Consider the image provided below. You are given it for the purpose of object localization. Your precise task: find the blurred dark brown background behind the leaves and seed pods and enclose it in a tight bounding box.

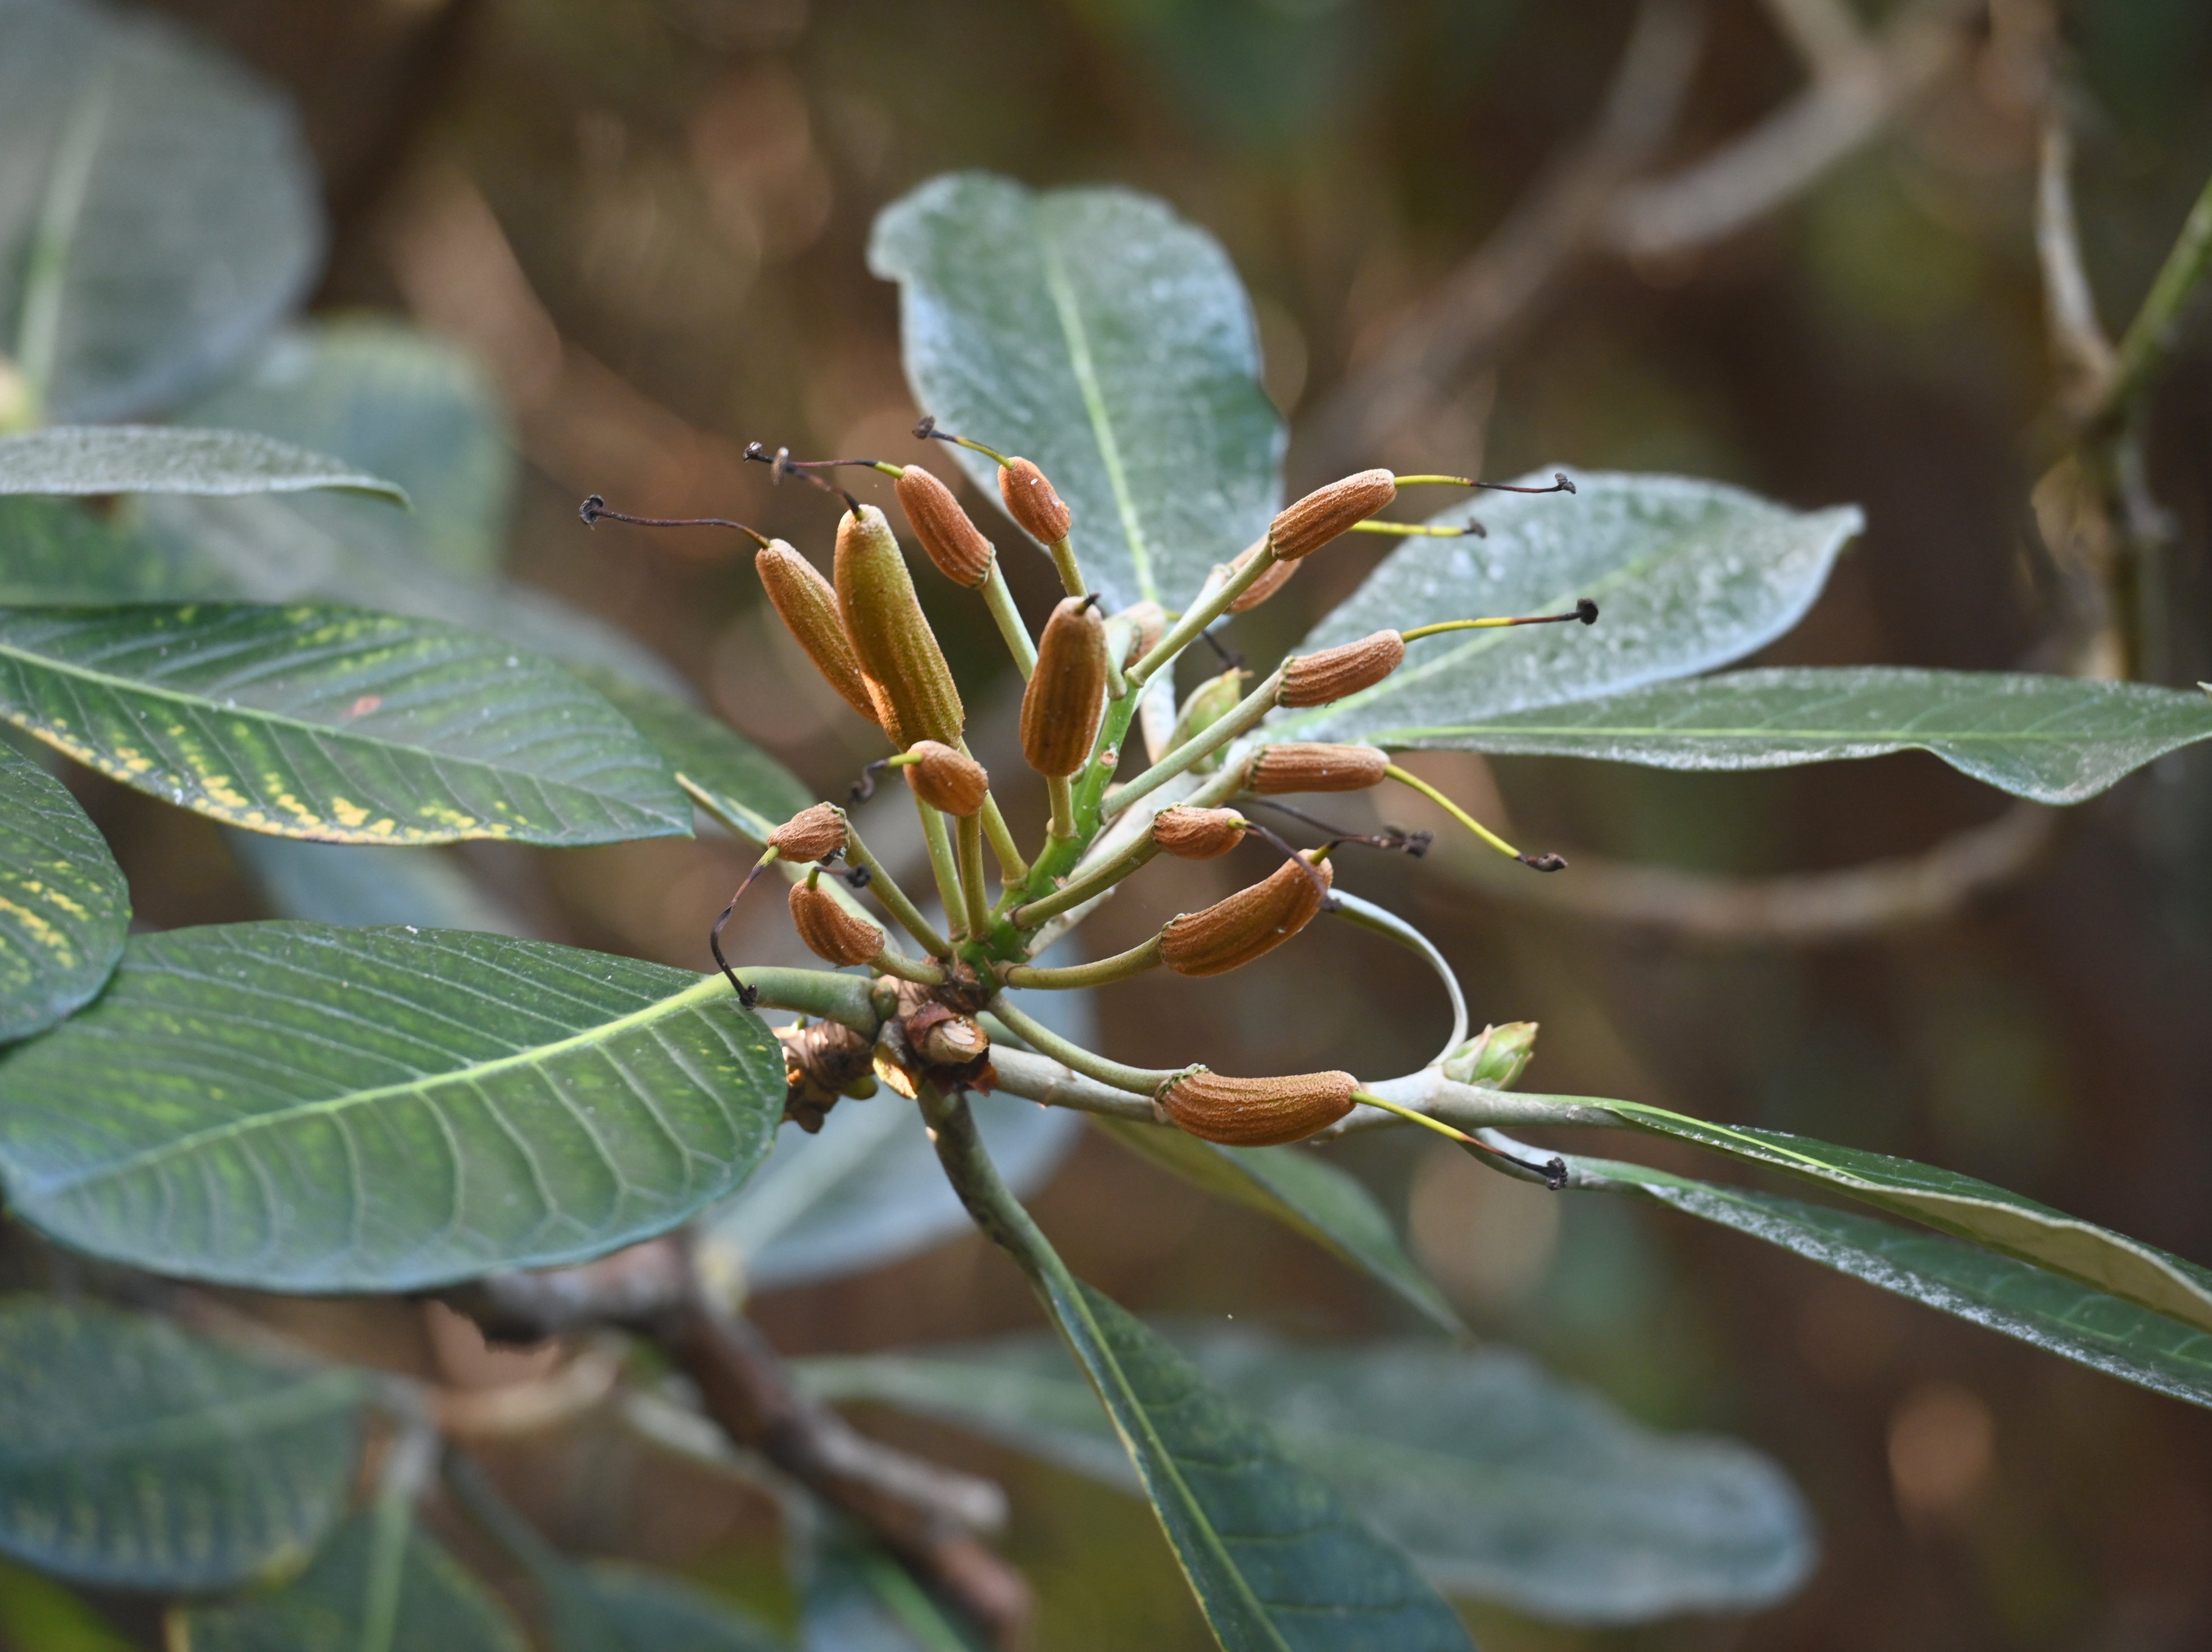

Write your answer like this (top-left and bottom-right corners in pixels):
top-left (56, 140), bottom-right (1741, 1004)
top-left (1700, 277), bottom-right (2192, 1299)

top-left (43, 0), bottom-right (2212, 1652)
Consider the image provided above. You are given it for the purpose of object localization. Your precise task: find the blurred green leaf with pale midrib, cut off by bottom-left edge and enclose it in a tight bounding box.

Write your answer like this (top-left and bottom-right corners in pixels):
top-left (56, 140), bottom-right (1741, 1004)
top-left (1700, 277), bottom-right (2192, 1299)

top-left (168, 1508), bottom-right (529, 1652)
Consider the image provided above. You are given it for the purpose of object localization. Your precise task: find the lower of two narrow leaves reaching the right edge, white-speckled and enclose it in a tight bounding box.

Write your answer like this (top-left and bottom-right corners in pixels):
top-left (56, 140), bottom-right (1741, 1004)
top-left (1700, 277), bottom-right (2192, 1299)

top-left (1568, 1159), bottom-right (2212, 1407)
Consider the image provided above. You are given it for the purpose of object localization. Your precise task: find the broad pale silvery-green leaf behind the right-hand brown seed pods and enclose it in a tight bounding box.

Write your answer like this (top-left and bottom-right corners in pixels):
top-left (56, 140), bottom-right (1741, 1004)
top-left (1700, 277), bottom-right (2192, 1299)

top-left (1263, 471), bottom-right (1860, 741)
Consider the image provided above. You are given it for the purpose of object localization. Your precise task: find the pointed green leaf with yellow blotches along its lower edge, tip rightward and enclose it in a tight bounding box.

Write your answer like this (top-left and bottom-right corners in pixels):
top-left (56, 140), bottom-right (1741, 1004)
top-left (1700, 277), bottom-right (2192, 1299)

top-left (0, 604), bottom-right (690, 845)
